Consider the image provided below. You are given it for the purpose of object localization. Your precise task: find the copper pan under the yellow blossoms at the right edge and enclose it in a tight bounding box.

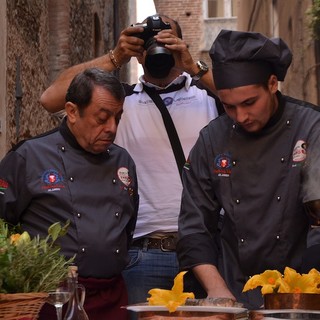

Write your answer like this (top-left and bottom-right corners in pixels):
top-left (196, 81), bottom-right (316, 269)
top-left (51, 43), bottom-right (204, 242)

top-left (264, 293), bottom-right (320, 310)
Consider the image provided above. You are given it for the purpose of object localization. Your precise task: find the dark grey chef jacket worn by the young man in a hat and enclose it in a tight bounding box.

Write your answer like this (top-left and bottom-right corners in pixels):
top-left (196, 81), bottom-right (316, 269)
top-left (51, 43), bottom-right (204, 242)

top-left (178, 92), bottom-right (320, 308)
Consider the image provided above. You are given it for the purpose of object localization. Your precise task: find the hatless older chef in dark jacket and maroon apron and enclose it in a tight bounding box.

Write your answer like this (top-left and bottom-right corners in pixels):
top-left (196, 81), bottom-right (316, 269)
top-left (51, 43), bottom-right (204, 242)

top-left (0, 69), bottom-right (138, 320)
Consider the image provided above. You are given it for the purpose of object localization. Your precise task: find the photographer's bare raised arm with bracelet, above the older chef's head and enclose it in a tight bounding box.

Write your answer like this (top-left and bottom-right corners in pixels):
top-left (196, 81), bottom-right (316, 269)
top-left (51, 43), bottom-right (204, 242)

top-left (40, 27), bottom-right (144, 113)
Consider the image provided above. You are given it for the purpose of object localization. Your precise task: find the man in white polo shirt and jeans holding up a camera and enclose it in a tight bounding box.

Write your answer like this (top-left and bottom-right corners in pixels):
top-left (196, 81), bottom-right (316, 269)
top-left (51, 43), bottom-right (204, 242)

top-left (41, 15), bottom-right (219, 316)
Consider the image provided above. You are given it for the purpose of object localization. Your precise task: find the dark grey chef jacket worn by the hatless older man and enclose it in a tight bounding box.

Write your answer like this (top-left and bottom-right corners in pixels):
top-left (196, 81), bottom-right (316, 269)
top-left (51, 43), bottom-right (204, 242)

top-left (0, 121), bottom-right (138, 278)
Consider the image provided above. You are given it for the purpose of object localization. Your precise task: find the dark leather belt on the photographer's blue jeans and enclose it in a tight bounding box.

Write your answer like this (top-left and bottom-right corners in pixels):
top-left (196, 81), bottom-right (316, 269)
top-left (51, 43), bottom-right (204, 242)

top-left (131, 235), bottom-right (177, 252)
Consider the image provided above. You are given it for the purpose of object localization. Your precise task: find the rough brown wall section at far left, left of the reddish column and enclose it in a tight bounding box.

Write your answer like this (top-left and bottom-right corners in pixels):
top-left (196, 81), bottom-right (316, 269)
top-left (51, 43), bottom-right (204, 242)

top-left (6, 0), bottom-right (55, 150)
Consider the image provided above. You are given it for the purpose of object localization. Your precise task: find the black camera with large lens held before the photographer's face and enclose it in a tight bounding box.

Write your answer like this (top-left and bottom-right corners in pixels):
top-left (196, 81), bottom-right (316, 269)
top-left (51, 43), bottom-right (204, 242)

top-left (133, 16), bottom-right (175, 78)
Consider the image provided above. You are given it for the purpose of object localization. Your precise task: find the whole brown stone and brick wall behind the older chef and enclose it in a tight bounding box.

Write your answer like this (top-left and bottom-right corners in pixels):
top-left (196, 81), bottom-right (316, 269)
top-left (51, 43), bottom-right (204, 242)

top-left (0, 0), bottom-right (129, 158)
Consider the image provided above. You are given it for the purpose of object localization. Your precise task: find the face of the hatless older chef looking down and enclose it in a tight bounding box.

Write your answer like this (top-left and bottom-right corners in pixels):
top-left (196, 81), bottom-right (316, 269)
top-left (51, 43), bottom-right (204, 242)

top-left (66, 86), bottom-right (123, 154)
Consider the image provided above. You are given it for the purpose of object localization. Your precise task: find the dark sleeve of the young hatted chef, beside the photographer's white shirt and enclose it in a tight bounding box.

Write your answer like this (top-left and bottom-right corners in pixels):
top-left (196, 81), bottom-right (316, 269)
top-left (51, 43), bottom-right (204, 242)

top-left (177, 130), bottom-right (220, 269)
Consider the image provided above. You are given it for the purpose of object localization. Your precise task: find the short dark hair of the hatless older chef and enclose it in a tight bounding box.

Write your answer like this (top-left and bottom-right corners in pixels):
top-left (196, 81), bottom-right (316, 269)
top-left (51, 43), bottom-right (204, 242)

top-left (66, 68), bottom-right (125, 114)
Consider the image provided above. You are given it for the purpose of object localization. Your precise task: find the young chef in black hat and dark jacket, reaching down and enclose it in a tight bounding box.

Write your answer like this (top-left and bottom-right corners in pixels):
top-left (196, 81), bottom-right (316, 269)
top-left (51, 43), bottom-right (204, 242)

top-left (177, 30), bottom-right (320, 309)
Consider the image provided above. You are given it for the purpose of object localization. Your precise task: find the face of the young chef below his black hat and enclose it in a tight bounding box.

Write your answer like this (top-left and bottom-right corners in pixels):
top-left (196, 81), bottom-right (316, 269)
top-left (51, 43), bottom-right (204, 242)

top-left (218, 76), bottom-right (278, 133)
